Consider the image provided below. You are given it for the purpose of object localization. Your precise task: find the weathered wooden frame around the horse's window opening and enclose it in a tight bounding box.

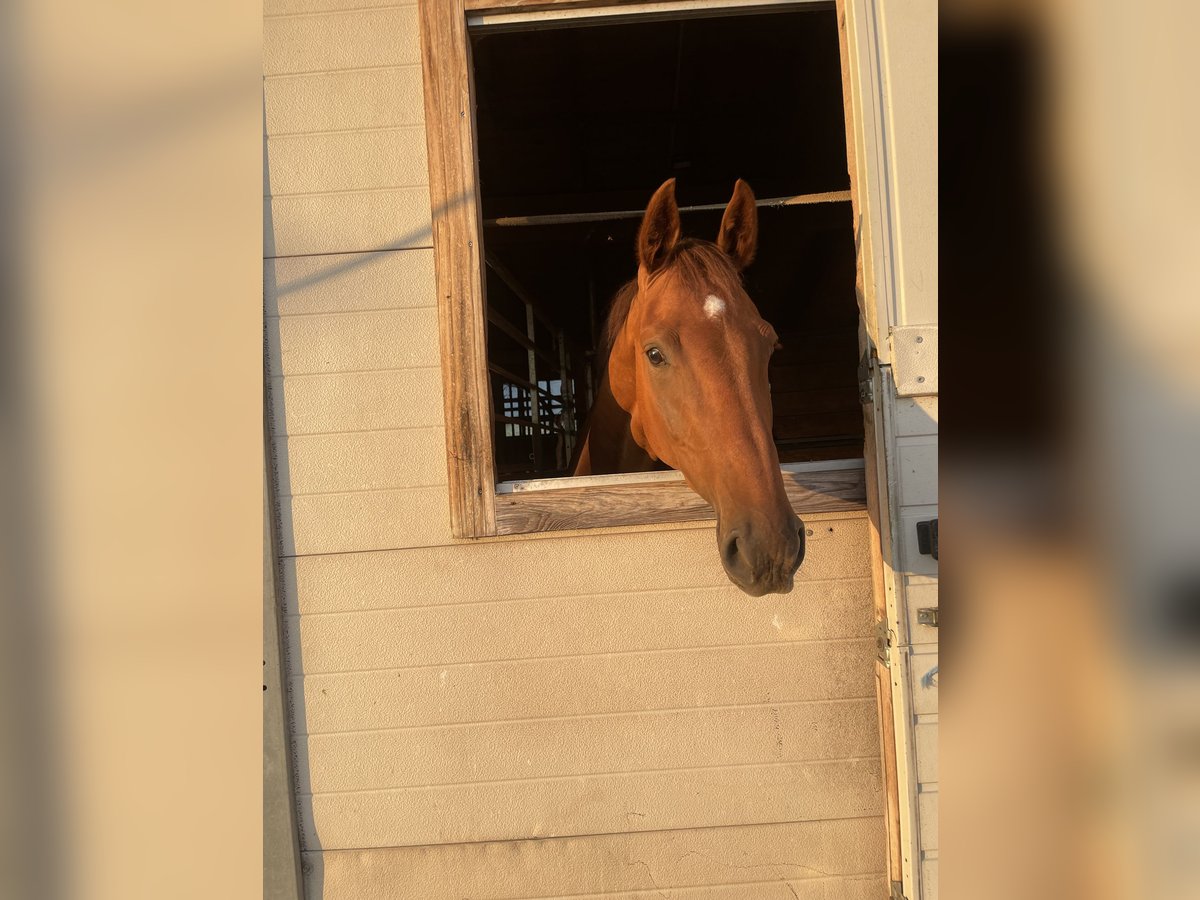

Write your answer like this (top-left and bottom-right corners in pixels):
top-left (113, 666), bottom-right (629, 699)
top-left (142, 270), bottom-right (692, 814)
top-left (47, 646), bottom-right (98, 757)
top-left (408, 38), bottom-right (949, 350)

top-left (418, 0), bottom-right (866, 538)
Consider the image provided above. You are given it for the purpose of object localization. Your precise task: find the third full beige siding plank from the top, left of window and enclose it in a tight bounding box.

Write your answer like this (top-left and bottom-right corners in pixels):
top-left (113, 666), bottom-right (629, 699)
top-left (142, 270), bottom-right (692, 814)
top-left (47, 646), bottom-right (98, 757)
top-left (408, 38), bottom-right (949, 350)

top-left (263, 125), bottom-right (428, 197)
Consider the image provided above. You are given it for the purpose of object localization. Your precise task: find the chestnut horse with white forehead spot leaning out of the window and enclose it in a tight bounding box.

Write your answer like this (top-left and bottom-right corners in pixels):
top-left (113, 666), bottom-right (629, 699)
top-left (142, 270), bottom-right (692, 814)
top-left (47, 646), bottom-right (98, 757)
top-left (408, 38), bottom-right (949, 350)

top-left (574, 179), bottom-right (804, 596)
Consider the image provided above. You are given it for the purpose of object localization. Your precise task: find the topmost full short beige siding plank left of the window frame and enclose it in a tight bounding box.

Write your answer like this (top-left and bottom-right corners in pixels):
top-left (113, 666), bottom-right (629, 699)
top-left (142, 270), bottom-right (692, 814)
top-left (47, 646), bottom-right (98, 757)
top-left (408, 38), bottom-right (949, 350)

top-left (263, 6), bottom-right (421, 76)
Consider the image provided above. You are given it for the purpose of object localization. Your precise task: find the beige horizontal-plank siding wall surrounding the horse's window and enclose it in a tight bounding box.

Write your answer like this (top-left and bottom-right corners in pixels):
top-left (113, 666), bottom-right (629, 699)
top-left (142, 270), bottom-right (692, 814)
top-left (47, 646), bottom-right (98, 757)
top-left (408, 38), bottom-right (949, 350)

top-left (264, 0), bottom-right (884, 900)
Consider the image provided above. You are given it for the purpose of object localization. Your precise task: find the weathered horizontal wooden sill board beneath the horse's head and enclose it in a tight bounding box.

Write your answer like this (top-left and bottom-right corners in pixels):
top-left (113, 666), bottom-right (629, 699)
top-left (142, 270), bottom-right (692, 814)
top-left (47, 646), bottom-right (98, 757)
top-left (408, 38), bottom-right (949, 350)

top-left (496, 467), bottom-right (866, 534)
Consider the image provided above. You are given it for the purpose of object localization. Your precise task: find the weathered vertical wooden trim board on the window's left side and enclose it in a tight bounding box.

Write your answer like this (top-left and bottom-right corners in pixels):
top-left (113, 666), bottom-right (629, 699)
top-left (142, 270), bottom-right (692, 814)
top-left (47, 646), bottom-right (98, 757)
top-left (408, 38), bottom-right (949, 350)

top-left (418, 0), bottom-right (496, 538)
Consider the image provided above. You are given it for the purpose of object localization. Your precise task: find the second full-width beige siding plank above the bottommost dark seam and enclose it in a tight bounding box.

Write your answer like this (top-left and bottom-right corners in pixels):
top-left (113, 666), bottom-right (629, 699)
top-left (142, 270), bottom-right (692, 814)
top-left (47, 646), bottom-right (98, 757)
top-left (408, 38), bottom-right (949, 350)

top-left (296, 698), bottom-right (878, 793)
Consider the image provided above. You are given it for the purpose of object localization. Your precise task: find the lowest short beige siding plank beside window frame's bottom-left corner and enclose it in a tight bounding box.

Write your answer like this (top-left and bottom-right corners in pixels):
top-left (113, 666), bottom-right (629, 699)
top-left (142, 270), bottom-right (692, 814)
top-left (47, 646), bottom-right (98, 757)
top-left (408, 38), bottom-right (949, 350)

top-left (280, 487), bottom-right (450, 556)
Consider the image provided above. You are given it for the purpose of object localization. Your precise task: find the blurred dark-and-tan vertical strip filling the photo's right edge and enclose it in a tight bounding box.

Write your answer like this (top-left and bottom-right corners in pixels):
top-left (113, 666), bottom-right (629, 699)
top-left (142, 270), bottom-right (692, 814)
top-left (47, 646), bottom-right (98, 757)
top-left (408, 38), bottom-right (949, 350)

top-left (940, 0), bottom-right (1200, 898)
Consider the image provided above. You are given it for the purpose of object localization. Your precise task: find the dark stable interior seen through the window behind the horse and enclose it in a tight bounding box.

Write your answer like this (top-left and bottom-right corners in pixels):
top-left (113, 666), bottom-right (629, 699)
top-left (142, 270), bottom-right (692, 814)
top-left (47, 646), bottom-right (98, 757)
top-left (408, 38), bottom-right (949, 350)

top-left (472, 4), bottom-right (863, 480)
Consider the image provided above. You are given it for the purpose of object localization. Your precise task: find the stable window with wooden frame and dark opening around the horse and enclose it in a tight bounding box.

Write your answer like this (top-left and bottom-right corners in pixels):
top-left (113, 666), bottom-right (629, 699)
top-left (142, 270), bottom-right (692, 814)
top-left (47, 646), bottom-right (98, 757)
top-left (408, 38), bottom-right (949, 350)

top-left (420, 0), bottom-right (865, 536)
